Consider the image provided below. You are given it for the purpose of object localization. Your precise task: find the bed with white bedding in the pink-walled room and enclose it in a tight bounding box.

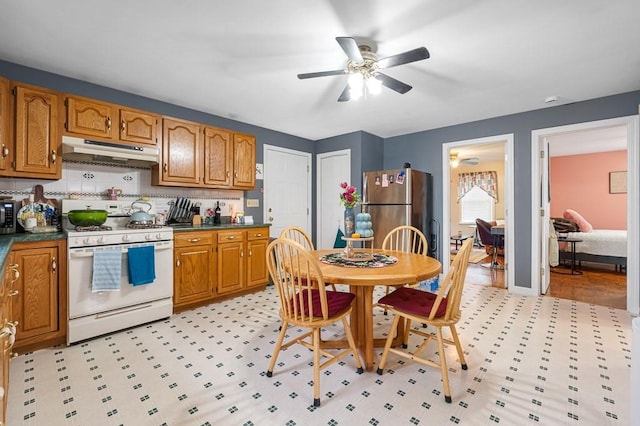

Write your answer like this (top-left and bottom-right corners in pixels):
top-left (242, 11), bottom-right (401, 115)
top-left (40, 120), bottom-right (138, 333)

top-left (558, 229), bottom-right (627, 268)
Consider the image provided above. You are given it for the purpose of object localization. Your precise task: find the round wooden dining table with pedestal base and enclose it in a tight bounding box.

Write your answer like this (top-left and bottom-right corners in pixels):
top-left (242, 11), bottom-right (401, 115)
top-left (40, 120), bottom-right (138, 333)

top-left (312, 249), bottom-right (442, 370)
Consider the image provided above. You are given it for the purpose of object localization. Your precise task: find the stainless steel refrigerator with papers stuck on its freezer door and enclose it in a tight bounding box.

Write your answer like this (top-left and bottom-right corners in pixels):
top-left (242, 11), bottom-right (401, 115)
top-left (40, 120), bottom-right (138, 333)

top-left (361, 168), bottom-right (436, 257)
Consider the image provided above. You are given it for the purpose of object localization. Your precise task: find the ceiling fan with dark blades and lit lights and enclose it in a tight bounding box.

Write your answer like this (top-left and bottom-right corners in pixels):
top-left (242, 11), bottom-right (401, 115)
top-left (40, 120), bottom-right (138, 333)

top-left (298, 37), bottom-right (429, 102)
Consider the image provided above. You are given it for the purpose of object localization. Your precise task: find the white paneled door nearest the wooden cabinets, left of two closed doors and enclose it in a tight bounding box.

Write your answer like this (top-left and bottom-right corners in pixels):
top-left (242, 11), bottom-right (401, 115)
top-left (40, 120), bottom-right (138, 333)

top-left (264, 145), bottom-right (311, 238)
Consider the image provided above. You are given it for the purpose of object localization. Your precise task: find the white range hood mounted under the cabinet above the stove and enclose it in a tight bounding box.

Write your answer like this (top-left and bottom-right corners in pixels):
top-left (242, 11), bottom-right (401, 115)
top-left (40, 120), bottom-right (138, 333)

top-left (62, 136), bottom-right (160, 167)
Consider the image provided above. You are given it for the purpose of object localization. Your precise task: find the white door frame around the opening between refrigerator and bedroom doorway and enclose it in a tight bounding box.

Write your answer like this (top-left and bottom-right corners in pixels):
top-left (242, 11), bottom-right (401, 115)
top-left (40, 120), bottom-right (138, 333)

top-left (442, 134), bottom-right (515, 291)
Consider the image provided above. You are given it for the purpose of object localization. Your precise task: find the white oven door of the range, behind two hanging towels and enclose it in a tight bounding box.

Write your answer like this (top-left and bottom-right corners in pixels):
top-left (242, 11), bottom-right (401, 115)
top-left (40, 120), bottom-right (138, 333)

top-left (68, 241), bottom-right (173, 320)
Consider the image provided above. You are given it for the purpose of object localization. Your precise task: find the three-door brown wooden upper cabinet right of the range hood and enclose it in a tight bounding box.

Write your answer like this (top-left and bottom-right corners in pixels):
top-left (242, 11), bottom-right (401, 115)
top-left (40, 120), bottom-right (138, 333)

top-left (151, 118), bottom-right (256, 190)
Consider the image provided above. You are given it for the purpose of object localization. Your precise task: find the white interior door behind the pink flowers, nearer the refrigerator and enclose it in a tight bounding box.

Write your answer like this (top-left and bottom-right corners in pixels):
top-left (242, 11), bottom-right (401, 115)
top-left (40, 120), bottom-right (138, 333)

top-left (316, 149), bottom-right (352, 249)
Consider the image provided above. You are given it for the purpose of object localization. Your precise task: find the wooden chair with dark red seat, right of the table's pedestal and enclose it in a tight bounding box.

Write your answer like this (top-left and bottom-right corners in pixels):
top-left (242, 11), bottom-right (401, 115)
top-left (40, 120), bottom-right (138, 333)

top-left (378, 238), bottom-right (473, 403)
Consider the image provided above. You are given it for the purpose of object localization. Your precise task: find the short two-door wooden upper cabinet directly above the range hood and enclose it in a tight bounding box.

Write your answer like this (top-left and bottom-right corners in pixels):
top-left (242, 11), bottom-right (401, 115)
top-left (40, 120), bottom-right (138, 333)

top-left (65, 96), bottom-right (159, 146)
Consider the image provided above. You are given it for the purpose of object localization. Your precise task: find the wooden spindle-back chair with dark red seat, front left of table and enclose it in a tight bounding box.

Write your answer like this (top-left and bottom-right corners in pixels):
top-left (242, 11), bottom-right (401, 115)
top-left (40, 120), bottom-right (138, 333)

top-left (267, 238), bottom-right (363, 407)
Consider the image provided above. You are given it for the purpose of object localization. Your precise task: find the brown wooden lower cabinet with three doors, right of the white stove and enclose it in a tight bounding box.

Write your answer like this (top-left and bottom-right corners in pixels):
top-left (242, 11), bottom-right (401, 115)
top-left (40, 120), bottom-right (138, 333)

top-left (173, 227), bottom-right (269, 312)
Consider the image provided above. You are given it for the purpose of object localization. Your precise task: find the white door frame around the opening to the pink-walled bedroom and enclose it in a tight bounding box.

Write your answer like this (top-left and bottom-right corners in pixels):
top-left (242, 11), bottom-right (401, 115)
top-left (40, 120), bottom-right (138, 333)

top-left (531, 116), bottom-right (640, 314)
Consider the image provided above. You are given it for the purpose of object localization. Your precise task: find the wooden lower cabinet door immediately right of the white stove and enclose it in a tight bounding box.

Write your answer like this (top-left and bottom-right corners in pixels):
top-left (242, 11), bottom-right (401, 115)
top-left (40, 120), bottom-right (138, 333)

top-left (173, 245), bottom-right (212, 306)
